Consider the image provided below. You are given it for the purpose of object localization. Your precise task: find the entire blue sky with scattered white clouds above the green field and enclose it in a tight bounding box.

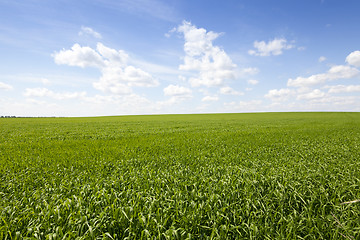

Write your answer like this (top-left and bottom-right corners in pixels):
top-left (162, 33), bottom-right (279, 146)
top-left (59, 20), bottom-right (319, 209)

top-left (0, 0), bottom-right (360, 116)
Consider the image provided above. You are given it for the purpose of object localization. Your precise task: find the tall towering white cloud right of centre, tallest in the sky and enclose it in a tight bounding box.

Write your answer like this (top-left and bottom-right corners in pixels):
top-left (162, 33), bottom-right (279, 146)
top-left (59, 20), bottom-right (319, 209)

top-left (177, 21), bottom-right (236, 87)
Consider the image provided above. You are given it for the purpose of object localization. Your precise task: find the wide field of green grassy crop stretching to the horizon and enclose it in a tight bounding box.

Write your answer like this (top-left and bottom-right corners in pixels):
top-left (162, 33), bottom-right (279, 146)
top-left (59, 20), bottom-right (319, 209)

top-left (0, 113), bottom-right (360, 239)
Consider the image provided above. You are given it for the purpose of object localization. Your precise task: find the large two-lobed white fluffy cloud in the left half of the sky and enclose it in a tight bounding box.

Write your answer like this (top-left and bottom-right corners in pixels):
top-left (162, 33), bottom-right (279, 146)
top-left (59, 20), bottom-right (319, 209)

top-left (53, 43), bottom-right (159, 95)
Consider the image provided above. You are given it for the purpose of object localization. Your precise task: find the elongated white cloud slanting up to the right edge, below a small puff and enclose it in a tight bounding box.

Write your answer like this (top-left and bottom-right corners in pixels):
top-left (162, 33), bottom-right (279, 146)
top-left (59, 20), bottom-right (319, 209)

top-left (287, 65), bottom-right (360, 87)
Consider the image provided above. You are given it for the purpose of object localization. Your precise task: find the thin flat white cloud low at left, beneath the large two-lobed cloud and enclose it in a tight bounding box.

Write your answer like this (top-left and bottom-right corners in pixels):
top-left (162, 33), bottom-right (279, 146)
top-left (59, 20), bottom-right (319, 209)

top-left (24, 88), bottom-right (86, 100)
